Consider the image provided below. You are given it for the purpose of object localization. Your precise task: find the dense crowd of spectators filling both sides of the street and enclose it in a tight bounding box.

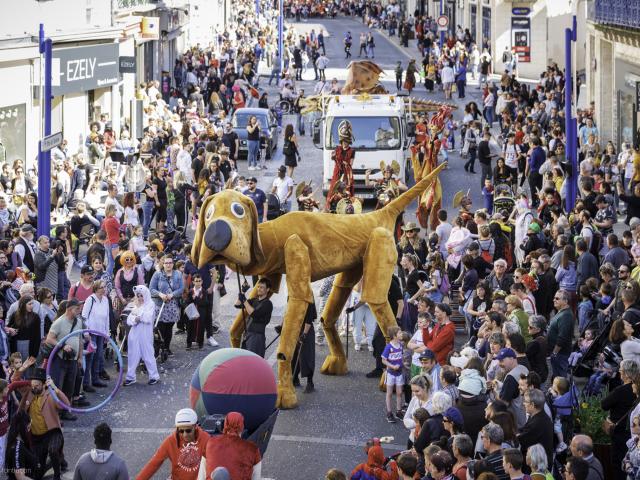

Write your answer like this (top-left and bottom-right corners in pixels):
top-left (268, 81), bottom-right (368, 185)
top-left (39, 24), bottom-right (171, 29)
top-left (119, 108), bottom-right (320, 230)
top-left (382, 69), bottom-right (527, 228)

top-left (0, 1), bottom-right (640, 480)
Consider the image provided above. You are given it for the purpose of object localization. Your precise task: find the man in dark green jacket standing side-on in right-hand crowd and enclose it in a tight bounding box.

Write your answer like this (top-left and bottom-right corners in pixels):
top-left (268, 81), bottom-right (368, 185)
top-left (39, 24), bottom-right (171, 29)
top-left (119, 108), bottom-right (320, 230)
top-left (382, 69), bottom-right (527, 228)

top-left (547, 290), bottom-right (575, 379)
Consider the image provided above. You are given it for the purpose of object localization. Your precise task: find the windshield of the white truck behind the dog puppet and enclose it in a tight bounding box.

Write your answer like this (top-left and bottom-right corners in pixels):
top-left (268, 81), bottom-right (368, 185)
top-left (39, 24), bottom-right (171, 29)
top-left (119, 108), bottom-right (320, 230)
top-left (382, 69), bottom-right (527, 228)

top-left (325, 117), bottom-right (401, 150)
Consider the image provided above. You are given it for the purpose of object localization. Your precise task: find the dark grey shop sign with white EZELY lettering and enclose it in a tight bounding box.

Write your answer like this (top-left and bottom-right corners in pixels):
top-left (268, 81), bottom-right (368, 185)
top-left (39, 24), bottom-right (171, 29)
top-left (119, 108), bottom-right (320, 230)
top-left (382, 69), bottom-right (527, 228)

top-left (52, 43), bottom-right (120, 96)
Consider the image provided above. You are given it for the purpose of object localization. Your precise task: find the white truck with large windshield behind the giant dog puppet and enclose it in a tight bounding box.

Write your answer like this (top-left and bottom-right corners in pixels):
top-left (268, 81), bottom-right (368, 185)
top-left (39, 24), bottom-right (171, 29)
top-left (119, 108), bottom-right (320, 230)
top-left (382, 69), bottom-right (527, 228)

top-left (313, 94), bottom-right (415, 200)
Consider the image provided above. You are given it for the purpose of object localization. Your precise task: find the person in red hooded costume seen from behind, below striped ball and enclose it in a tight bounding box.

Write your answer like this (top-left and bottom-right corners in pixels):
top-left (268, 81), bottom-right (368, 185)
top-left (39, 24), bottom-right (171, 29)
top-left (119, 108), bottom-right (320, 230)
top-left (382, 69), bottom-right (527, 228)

top-left (205, 412), bottom-right (262, 480)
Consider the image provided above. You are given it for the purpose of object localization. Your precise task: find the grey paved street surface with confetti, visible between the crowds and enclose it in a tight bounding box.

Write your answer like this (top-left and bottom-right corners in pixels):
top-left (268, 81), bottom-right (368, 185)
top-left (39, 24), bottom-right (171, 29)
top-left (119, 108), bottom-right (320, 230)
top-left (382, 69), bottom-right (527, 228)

top-left (65, 18), bottom-right (488, 480)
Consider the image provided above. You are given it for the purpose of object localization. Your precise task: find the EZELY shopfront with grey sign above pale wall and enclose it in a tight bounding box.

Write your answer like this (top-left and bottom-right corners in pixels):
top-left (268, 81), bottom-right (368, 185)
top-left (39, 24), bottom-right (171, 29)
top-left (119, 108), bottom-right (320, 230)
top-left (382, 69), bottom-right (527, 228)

top-left (51, 43), bottom-right (120, 155)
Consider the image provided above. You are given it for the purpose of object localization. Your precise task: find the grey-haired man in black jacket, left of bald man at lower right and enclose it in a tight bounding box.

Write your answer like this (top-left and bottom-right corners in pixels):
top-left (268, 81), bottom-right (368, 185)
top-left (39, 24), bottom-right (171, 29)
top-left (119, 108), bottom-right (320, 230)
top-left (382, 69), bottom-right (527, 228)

top-left (518, 389), bottom-right (553, 465)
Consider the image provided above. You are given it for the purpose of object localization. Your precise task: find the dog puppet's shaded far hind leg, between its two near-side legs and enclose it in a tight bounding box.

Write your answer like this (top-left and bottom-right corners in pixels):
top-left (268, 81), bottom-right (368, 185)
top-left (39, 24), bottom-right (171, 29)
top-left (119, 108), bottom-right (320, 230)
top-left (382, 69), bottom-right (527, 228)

top-left (320, 267), bottom-right (362, 375)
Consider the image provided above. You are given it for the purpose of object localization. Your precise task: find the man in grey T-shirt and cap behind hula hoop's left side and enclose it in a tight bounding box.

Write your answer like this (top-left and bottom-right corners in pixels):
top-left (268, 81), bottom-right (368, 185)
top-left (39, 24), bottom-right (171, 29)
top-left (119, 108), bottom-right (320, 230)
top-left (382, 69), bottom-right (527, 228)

top-left (46, 298), bottom-right (83, 421)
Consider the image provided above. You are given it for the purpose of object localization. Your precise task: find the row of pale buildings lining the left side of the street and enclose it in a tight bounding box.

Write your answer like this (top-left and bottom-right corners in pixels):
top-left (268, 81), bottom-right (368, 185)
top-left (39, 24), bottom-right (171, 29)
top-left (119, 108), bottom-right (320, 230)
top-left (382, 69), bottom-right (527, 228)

top-left (0, 0), bottom-right (229, 168)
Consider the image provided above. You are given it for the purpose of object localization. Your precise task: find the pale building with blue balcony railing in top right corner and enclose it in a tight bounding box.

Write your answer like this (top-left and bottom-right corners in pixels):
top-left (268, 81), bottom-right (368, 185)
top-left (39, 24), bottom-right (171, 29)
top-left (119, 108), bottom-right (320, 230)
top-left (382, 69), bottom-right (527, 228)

top-left (586, 0), bottom-right (640, 148)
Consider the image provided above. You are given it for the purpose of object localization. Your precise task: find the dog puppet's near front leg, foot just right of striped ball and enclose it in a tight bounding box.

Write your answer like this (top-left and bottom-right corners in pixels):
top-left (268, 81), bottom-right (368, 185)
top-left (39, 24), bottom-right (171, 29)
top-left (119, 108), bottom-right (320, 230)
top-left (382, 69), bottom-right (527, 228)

top-left (277, 235), bottom-right (313, 408)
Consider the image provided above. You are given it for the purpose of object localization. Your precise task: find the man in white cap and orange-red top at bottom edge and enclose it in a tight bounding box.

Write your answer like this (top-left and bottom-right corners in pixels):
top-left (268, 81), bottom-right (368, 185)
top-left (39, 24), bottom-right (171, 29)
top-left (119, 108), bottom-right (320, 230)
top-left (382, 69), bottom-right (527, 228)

top-left (136, 408), bottom-right (209, 480)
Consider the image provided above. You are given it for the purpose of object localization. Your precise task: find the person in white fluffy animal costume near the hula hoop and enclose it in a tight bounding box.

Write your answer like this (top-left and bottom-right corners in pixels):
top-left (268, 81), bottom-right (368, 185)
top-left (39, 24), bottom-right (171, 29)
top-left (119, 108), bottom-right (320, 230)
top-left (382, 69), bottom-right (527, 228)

top-left (124, 285), bottom-right (160, 387)
